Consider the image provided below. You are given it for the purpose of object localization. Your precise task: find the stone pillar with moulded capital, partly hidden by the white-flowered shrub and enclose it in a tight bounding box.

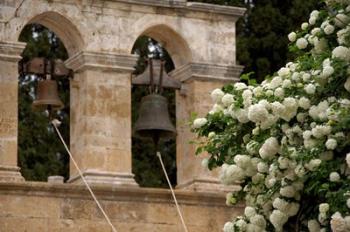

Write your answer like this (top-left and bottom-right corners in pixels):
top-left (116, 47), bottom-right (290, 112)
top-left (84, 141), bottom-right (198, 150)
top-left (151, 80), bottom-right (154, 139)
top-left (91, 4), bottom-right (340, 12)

top-left (171, 63), bottom-right (242, 191)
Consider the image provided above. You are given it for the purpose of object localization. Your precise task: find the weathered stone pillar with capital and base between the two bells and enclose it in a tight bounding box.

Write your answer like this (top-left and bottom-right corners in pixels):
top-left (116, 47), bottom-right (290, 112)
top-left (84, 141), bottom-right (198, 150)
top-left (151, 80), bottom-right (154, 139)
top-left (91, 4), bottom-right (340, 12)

top-left (66, 51), bottom-right (137, 186)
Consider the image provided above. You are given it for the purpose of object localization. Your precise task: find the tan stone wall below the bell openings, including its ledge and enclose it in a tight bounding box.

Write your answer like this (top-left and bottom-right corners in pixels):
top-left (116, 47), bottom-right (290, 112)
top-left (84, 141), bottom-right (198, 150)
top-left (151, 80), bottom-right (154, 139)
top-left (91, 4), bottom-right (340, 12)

top-left (0, 182), bottom-right (242, 232)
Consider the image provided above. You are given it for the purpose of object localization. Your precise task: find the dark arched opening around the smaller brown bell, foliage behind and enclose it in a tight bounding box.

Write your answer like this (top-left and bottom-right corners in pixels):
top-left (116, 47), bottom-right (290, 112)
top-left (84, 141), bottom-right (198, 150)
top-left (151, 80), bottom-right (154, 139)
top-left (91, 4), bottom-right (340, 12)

top-left (18, 24), bottom-right (70, 181)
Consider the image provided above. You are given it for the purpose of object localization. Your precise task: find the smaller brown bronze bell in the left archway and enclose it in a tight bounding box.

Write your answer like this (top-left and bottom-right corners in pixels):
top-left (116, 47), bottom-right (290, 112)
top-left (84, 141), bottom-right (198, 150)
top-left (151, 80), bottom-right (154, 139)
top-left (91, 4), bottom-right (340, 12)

top-left (32, 80), bottom-right (64, 110)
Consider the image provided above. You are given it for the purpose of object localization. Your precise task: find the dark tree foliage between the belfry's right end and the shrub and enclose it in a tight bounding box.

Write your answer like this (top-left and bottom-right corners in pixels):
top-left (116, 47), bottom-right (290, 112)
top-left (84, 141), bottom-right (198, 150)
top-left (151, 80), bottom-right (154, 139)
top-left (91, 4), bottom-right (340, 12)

top-left (237, 0), bottom-right (321, 82)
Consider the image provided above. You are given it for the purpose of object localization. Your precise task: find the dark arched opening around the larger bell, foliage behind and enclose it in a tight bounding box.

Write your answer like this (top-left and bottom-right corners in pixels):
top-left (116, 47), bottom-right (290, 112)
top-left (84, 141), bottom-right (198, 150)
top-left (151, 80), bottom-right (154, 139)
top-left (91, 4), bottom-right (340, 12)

top-left (132, 36), bottom-right (176, 187)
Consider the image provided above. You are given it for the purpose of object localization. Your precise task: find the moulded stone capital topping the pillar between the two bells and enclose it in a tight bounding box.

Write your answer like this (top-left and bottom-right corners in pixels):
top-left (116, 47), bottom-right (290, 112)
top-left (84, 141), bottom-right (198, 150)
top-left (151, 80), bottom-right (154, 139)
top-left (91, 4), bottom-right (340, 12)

top-left (65, 51), bottom-right (138, 72)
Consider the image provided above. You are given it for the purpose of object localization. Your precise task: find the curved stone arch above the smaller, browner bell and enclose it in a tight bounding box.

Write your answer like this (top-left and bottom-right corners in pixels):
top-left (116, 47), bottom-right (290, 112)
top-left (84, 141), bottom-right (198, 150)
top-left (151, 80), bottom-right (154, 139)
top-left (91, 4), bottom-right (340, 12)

top-left (17, 11), bottom-right (85, 57)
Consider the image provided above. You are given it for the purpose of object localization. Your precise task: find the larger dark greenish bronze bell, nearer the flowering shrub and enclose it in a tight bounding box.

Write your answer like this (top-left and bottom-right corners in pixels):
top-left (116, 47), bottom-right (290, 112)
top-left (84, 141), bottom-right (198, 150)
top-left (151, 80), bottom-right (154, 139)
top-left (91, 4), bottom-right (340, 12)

top-left (134, 94), bottom-right (176, 143)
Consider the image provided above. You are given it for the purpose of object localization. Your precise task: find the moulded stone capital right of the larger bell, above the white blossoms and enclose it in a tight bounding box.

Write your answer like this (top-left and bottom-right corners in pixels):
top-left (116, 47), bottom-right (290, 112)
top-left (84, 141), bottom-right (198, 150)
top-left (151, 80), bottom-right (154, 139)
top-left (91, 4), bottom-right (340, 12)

top-left (170, 63), bottom-right (243, 82)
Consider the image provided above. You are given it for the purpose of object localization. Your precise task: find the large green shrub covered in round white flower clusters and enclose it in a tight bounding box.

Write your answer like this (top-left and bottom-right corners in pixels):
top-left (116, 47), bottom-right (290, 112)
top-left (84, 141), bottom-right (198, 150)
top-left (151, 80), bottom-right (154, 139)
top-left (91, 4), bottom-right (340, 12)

top-left (193, 0), bottom-right (350, 232)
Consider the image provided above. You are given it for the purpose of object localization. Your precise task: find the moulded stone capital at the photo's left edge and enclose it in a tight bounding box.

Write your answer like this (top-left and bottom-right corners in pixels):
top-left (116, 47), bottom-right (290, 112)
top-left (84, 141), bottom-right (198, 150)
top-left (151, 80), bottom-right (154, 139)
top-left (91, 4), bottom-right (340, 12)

top-left (0, 41), bottom-right (26, 62)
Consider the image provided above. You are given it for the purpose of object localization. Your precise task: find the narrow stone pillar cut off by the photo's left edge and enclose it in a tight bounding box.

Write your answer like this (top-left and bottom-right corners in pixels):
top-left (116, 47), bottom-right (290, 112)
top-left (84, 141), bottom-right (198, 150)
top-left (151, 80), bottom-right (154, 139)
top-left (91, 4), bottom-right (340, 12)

top-left (0, 41), bottom-right (25, 182)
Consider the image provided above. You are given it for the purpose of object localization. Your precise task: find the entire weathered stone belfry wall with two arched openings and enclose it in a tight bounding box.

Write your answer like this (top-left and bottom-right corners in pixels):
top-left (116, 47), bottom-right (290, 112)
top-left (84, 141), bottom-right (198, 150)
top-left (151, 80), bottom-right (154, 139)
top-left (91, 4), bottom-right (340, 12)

top-left (0, 0), bottom-right (244, 232)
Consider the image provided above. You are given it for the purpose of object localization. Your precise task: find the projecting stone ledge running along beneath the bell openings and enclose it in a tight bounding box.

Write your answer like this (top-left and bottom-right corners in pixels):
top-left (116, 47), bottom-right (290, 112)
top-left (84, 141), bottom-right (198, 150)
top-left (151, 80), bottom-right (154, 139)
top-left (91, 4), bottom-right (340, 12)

top-left (0, 182), bottom-right (235, 207)
